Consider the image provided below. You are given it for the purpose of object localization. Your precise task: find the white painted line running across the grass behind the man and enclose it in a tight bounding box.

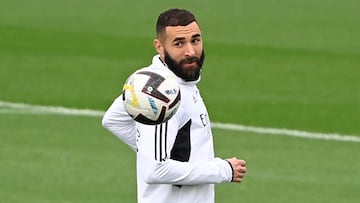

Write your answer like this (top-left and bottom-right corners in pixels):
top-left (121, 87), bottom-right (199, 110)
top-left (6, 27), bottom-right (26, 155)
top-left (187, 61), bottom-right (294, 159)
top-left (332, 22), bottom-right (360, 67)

top-left (0, 100), bottom-right (360, 142)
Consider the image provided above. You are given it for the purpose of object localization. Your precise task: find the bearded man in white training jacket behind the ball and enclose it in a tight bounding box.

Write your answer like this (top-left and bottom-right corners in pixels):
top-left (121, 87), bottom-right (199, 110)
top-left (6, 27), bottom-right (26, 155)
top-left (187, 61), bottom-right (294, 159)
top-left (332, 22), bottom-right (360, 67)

top-left (103, 9), bottom-right (246, 203)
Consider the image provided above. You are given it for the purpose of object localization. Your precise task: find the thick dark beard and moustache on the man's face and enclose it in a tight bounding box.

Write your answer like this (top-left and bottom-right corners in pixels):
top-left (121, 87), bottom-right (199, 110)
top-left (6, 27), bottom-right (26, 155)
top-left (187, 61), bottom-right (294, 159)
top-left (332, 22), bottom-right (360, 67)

top-left (164, 50), bottom-right (205, 81)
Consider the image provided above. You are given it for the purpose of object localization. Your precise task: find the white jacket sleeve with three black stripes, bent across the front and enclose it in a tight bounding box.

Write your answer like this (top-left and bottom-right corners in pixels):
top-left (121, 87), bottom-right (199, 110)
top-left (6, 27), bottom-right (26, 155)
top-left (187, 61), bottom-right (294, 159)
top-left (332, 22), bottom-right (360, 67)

top-left (137, 116), bottom-right (233, 185)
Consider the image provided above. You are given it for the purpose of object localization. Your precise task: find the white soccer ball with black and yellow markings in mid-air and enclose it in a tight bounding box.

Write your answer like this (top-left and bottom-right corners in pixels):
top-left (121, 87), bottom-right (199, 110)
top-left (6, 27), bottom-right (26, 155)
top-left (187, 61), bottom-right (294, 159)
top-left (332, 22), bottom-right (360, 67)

top-left (122, 69), bottom-right (180, 125)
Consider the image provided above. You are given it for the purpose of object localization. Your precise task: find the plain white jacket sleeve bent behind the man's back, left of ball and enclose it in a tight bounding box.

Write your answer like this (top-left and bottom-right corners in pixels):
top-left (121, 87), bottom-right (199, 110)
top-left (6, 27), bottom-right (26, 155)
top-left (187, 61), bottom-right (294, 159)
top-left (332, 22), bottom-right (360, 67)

top-left (102, 95), bottom-right (137, 151)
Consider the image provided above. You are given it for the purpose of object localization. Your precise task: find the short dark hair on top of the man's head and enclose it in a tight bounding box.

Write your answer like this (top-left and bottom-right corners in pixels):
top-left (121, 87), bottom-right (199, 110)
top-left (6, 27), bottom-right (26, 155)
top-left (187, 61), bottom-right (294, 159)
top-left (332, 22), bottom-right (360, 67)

top-left (156, 8), bottom-right (197, 37)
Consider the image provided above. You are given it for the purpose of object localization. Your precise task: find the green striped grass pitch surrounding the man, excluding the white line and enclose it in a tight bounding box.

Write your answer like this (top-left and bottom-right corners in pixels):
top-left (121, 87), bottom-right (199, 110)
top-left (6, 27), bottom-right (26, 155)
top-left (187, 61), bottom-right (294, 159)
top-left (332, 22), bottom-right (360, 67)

top-left (0, 0), bottom-right (360, 203)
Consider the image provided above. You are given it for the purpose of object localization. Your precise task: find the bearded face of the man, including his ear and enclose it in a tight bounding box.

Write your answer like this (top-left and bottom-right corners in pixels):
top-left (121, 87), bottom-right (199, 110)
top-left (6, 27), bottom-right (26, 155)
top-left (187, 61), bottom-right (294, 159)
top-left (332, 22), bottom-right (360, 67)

top-left (155, 22), bottom-right (205, 81)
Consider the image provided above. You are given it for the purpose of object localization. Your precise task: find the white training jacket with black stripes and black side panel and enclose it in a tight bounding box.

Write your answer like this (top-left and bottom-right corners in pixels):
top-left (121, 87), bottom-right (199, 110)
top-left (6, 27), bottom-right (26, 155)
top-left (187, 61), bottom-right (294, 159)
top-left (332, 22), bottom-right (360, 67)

top-left (102, 55), bottom-right (233, 203)
